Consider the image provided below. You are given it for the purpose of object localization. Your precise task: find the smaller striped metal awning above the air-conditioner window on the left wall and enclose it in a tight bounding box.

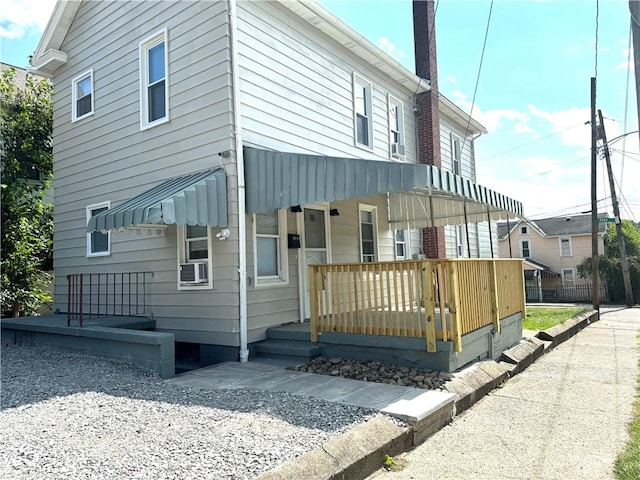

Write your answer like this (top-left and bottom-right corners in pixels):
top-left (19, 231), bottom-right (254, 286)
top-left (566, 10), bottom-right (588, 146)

top-left (87, 167), bottom-right (227, 233)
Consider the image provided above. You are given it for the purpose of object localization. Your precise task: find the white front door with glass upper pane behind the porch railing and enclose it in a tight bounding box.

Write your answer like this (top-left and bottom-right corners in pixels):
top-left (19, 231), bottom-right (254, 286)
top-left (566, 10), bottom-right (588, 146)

top-left (302, 205), bottom-right (331, 318)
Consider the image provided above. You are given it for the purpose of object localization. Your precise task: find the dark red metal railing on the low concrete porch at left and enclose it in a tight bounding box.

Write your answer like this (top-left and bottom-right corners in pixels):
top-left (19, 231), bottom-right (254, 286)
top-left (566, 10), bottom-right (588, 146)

top-left (67, 272), bottom-right (152, 327)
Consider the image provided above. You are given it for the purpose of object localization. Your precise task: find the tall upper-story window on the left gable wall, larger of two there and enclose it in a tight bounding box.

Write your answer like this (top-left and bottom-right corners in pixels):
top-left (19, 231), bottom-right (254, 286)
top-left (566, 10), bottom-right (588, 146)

top-left (140, 29), bottom-right (169, 129)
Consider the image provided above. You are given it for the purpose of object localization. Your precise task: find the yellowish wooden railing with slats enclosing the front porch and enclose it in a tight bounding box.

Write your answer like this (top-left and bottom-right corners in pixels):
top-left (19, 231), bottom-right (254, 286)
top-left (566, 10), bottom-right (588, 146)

top-left (309, 259), bottom-right (525, 352)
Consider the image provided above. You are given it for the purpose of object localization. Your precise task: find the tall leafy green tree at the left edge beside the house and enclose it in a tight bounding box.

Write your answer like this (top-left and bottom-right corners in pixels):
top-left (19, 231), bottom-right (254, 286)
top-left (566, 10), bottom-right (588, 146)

top-left (0, 65), bottom-right (53, 316)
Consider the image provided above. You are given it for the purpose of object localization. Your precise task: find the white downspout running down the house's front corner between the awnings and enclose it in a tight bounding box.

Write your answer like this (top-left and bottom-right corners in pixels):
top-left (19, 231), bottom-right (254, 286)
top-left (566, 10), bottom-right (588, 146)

top-left (229, 0), bottom-right (249, 363)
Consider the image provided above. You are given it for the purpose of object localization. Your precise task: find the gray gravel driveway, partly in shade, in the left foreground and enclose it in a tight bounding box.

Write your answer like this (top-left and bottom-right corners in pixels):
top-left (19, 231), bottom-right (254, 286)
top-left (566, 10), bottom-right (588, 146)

top-left (0, 344), bottom-right (374, 480)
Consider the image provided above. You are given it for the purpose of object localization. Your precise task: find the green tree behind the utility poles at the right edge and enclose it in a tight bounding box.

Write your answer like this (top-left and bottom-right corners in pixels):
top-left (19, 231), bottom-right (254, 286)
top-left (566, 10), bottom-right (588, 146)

top-left (578, 220), bottom-right (640, 302)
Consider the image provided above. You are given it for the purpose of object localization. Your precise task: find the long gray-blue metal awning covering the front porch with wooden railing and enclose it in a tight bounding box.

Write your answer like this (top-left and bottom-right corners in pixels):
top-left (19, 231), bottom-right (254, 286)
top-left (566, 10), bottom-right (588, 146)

top-left (244, 147), bottom-right (522, 229)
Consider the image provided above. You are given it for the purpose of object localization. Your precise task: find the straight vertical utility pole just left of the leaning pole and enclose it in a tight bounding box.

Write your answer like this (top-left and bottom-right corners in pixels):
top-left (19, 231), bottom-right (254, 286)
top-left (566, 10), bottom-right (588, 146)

top-left (591, 77), bottom-right (600, 318)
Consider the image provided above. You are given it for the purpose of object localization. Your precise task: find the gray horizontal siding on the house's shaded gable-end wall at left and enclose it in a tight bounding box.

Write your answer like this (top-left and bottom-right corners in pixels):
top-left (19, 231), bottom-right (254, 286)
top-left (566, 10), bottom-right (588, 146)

top-left (49, 1), bottom-right (238, 344)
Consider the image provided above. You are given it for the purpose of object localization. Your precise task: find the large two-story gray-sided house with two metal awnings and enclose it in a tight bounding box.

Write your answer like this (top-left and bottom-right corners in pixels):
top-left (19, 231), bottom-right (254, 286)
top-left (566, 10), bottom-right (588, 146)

top-left (33, 0), bottom-right (522, 360)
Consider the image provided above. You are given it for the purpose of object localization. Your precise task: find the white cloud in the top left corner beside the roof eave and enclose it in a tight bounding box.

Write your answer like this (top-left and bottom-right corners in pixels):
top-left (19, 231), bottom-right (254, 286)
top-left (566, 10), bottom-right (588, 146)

top-left (0, 0), bottom-right (55, 38)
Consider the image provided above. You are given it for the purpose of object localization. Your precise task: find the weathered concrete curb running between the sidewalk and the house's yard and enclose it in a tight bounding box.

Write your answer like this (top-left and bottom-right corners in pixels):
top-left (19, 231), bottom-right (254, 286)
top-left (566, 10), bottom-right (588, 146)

top-left (258, 310), bottom-right (599, 480)
